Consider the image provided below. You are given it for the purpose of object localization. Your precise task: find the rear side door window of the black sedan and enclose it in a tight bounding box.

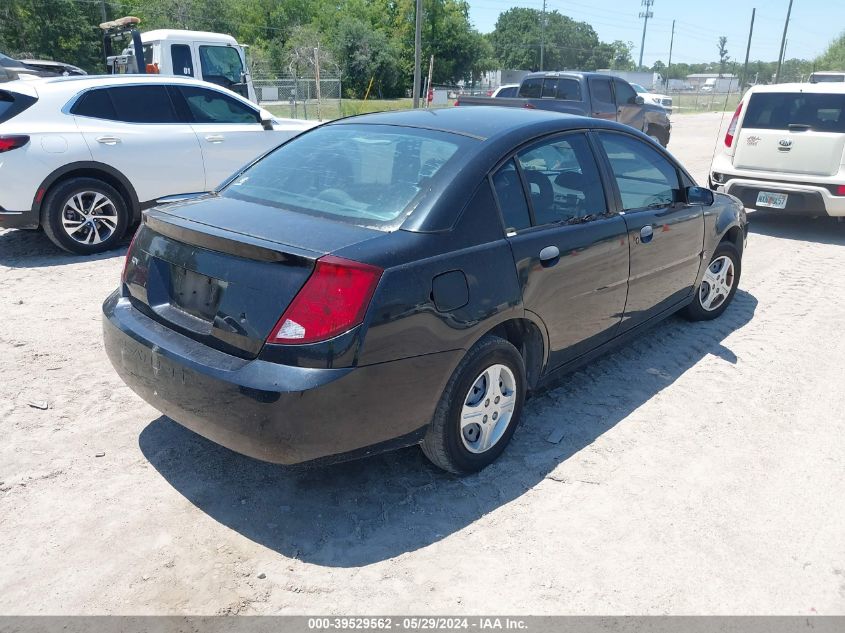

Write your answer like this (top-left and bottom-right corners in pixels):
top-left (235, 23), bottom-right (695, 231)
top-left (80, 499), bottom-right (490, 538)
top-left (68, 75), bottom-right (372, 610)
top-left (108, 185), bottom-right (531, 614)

top-left (517, 134), bottom-right (607, 225)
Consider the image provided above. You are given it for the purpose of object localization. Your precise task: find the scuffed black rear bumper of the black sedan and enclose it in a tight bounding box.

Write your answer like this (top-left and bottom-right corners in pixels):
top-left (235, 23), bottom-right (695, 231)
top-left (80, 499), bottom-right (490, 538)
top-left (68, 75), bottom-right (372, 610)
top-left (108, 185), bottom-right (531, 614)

top-left (103, 292), bottom-right (461, 464)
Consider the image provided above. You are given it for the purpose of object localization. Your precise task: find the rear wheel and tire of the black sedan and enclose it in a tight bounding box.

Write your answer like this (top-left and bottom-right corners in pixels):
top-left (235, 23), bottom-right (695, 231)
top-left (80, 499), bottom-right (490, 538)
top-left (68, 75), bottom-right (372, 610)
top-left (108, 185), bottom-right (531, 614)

top-left (422, 335), bottom-right (527, 475)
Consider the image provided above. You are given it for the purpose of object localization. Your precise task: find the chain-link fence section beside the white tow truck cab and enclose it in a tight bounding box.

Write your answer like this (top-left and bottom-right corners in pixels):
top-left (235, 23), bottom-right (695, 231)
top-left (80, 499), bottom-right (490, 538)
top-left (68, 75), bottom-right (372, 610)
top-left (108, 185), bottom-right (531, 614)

top-left (252, 73), bottom-right (343, 119)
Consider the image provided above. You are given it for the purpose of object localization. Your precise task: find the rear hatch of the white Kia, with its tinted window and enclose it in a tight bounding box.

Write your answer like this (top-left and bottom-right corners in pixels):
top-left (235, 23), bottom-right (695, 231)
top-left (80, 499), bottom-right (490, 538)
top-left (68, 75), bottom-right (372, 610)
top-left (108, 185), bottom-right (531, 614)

top-left (733, 92), bottom-right (845, 176)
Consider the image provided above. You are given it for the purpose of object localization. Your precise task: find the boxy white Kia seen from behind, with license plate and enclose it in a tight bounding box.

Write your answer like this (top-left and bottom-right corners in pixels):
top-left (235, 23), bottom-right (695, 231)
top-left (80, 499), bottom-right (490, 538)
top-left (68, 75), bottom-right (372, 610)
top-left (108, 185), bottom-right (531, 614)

top-left (710, 83), bottom-right (845, 217)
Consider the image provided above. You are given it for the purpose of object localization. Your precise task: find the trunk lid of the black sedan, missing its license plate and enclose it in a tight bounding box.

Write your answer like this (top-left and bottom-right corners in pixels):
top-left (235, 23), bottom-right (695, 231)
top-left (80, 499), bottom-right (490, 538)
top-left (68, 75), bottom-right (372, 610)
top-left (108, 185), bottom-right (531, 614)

top-left (124, 198), bottom-right (380, 358)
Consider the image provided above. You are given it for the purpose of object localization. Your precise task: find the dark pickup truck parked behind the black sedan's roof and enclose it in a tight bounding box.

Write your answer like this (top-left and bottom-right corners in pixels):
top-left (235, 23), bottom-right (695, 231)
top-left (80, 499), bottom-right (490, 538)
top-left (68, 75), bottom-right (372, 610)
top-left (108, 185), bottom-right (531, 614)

top-left (455, 72), bottom-right (672, 147)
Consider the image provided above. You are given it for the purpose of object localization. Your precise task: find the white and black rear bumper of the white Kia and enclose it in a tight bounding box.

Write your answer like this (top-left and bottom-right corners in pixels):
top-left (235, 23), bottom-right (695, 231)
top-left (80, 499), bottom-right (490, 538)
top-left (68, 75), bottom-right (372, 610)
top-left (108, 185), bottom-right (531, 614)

top-left (710, 170), bottom-right (845, 217)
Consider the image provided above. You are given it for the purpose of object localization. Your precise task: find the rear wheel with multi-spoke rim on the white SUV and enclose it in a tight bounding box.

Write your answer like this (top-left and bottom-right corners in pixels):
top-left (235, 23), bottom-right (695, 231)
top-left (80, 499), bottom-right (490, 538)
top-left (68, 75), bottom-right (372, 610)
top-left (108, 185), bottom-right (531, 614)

top-left (41, 178), bottom-right (129, 255)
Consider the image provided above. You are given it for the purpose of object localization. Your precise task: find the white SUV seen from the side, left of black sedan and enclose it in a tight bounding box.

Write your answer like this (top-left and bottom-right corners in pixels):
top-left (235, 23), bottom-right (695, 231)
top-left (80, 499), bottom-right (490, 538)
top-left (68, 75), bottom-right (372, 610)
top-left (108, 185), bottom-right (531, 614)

top-left (0, 75), bottom-right (314, 254)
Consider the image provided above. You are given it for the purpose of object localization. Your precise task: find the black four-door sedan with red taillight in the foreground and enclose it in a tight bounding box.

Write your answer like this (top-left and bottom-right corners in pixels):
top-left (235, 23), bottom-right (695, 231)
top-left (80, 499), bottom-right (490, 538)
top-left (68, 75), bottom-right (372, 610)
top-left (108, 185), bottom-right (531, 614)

top-left (103, 107), bottom-right (746, 473)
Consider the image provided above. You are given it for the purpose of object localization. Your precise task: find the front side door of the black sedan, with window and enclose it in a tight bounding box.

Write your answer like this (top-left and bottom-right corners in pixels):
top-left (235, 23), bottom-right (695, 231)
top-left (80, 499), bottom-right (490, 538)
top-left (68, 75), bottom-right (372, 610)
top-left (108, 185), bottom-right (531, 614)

top-left (596, 132), bottom-right (704, 331)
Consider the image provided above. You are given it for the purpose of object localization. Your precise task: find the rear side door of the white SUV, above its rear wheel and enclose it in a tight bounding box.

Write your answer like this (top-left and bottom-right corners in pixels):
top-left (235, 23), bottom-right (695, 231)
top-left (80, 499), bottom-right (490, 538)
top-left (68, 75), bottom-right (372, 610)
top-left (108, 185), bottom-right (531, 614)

top-left (71, 84), bottom-right (205, 204)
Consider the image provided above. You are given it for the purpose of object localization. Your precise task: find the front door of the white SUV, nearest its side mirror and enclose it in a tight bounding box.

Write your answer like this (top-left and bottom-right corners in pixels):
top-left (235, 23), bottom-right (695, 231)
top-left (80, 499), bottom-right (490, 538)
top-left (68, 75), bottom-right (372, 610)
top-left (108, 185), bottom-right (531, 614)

top-left (174, 86), bottom-right (282, 190)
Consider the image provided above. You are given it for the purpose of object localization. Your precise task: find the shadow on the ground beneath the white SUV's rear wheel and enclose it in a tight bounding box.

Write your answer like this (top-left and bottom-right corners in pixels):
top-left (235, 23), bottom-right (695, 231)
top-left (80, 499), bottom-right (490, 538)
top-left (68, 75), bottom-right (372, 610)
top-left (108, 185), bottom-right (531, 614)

top-left (0, 229), bottom-right (132, 268)
